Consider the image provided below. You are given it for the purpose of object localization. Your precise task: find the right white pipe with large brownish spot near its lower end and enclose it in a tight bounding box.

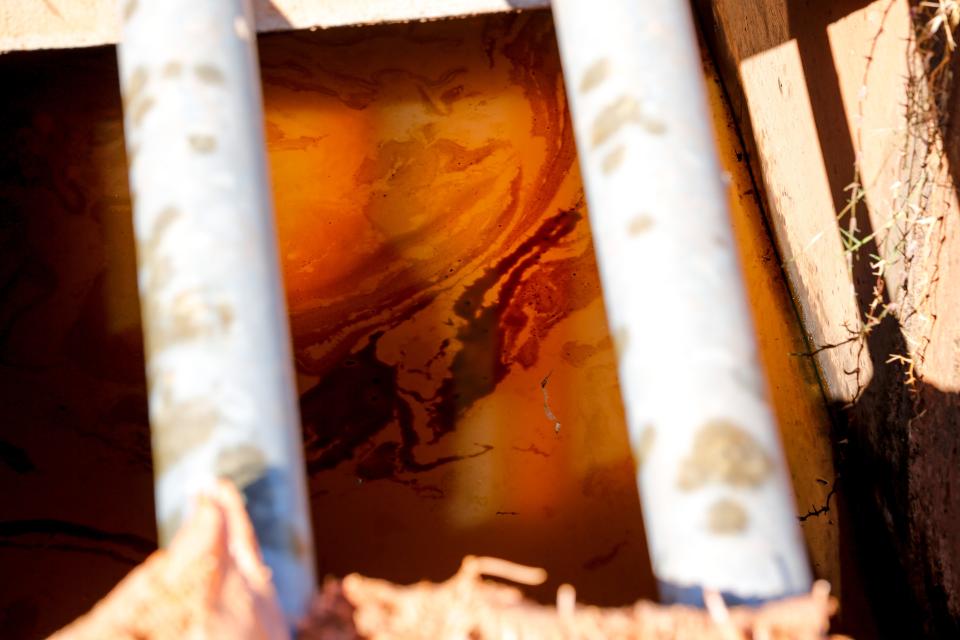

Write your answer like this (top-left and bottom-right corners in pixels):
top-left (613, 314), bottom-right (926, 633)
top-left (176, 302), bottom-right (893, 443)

top-left (553, 0), bottom-right (811, 604)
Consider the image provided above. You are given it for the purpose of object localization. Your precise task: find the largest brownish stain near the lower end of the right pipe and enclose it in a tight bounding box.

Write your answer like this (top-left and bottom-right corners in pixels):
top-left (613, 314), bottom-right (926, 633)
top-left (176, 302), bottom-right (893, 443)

top-left (677, 419), bottom-right (773, 491)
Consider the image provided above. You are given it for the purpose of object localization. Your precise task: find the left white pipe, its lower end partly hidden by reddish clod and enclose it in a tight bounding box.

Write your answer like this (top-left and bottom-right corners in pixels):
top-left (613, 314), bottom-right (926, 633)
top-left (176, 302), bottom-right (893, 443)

top-left (119, 0), bottom-right (315, 621)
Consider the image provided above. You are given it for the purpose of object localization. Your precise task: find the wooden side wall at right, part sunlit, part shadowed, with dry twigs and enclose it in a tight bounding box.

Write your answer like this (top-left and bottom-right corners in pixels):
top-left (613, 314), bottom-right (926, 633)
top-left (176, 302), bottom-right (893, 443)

top-left (699, 0), bottom-right (960, 636)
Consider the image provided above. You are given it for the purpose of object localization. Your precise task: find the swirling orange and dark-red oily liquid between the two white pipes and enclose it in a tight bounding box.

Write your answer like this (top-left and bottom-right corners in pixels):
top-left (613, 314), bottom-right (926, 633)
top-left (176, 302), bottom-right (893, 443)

top-left (261, 13), bottom-right (652, 603)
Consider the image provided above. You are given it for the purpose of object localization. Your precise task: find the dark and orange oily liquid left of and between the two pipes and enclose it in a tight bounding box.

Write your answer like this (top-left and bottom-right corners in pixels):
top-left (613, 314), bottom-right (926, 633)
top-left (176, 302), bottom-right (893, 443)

top-left (0, 12), bottom-right (653, 638)
